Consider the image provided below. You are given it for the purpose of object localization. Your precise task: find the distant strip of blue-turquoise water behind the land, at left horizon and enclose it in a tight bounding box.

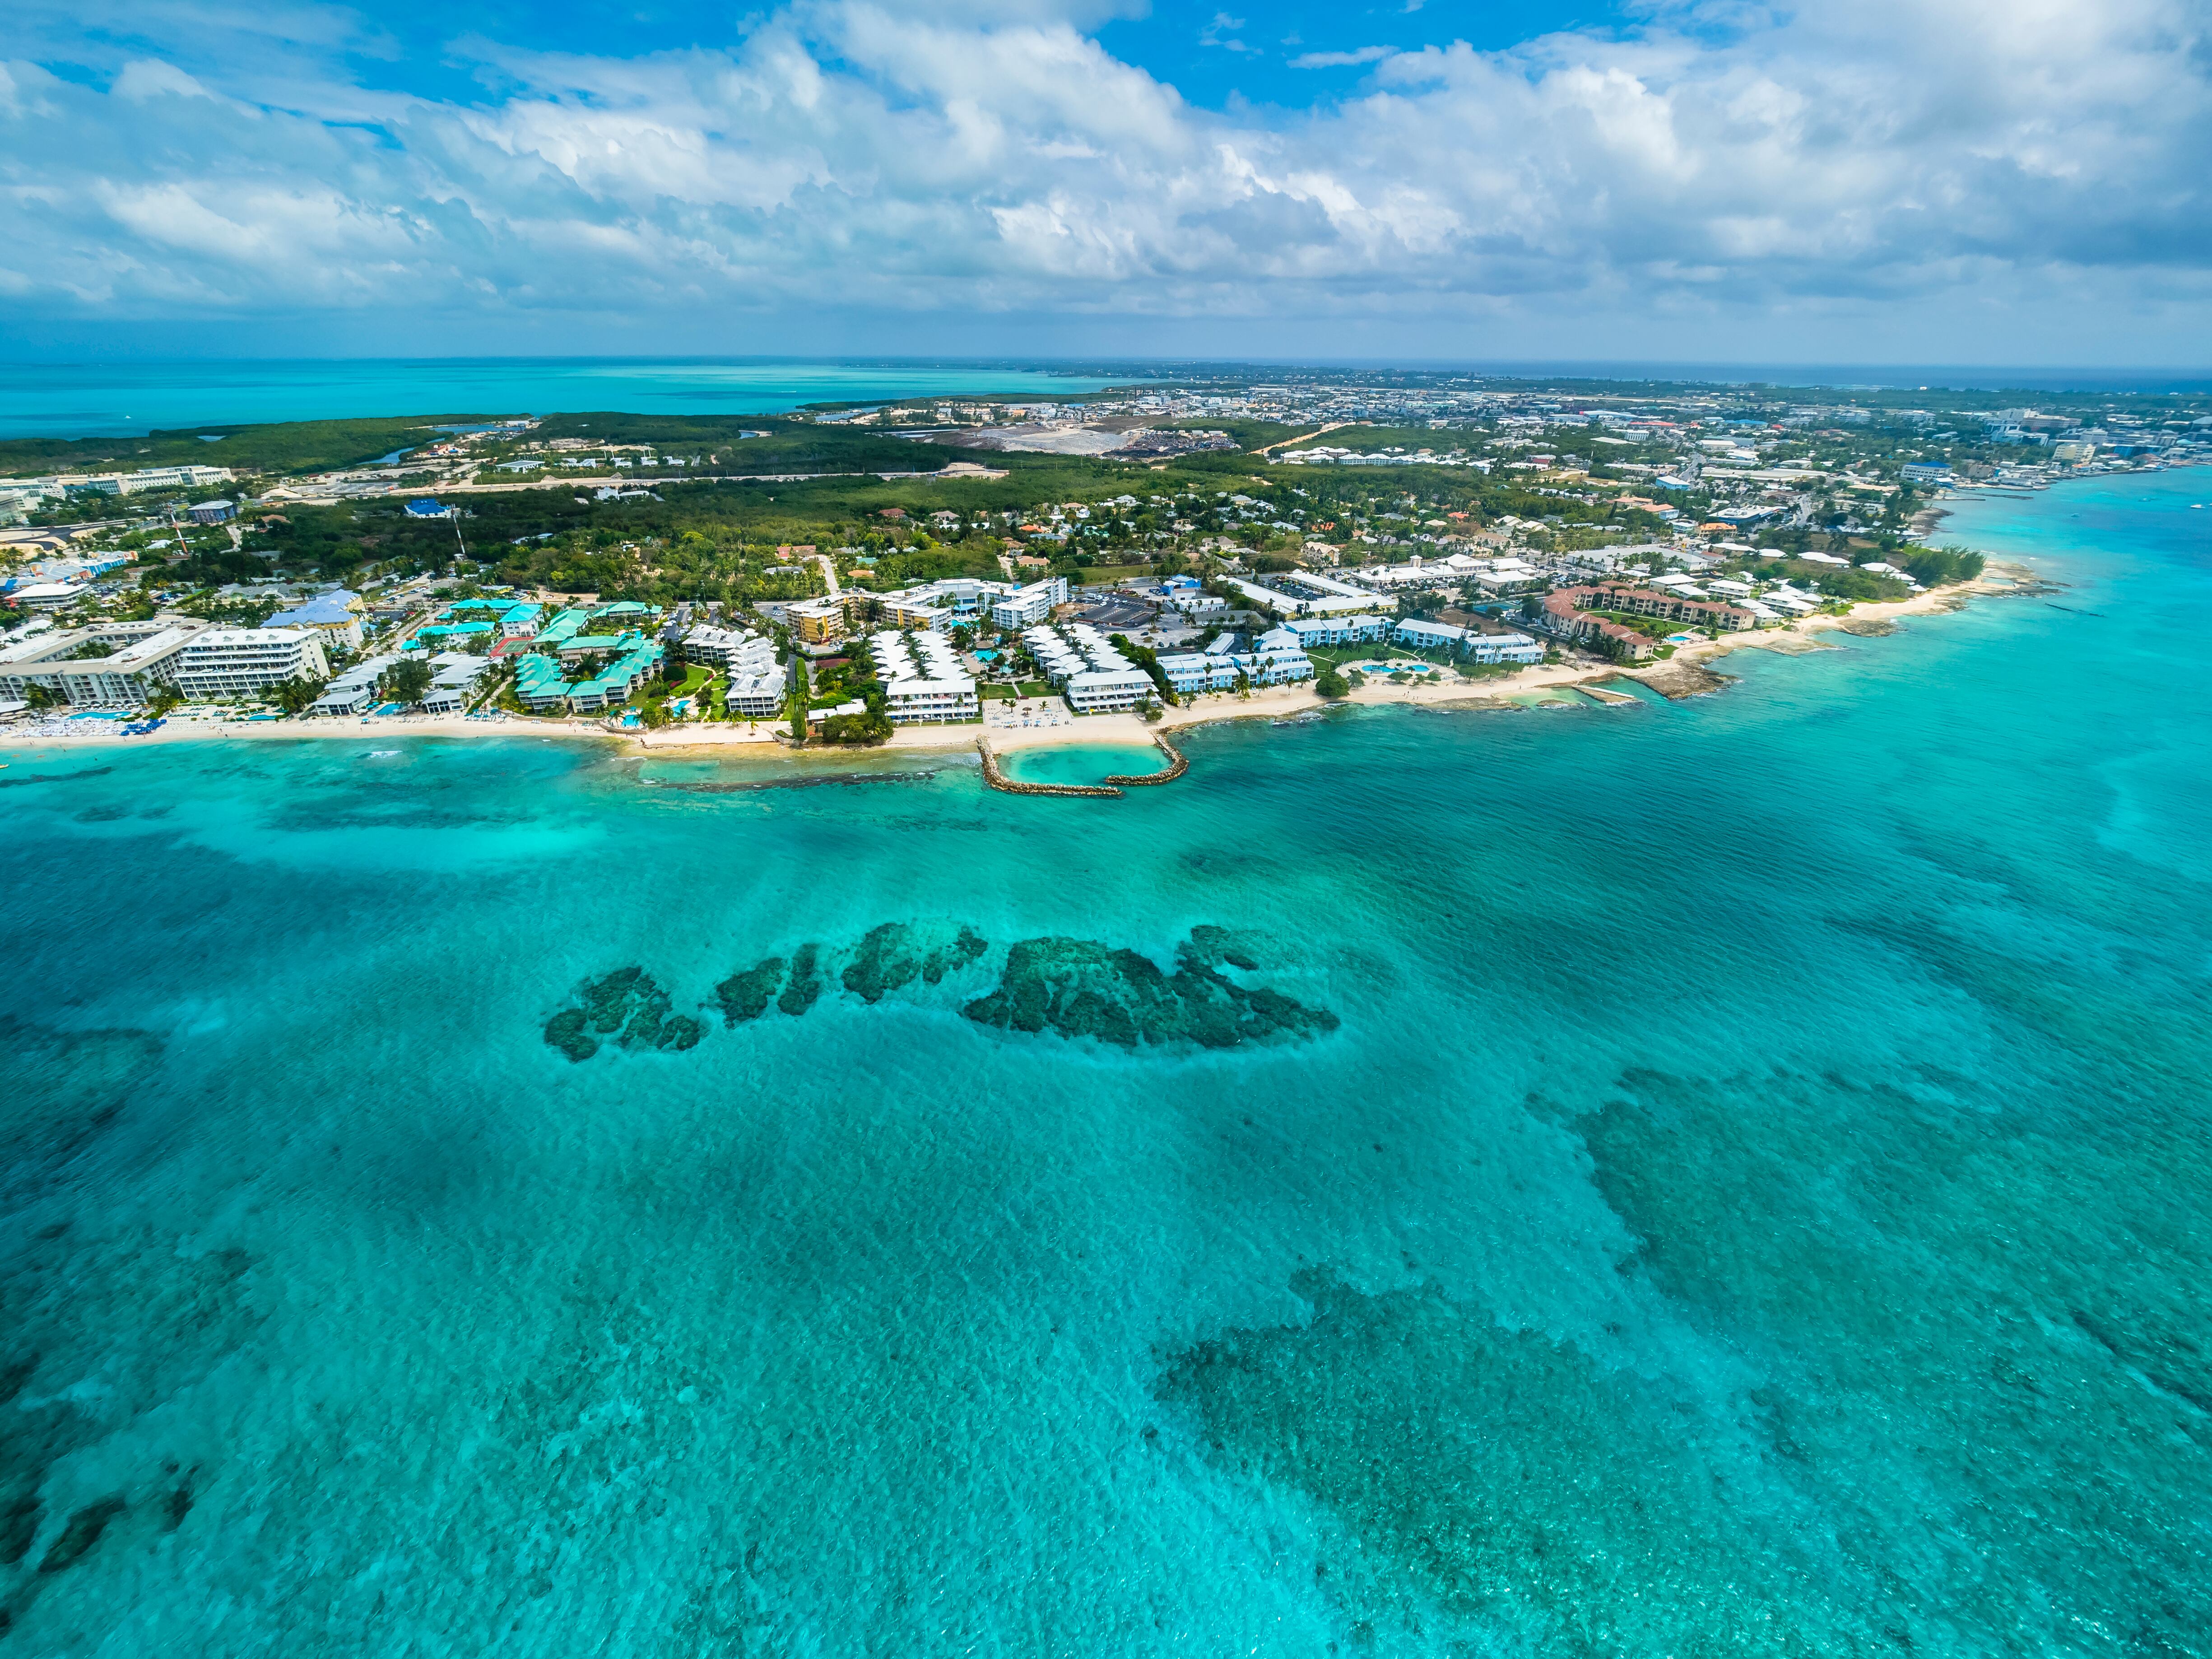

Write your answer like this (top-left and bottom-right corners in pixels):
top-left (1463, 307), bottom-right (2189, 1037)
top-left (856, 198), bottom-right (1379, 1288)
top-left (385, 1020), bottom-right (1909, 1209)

top-left (0, 358), bottom-right (1141, 438)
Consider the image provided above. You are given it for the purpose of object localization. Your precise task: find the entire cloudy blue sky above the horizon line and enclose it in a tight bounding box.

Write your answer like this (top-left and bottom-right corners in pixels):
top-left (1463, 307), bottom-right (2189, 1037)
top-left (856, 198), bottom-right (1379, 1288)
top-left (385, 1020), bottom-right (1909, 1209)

top-left (0, 0), bottom-right (2212, 369)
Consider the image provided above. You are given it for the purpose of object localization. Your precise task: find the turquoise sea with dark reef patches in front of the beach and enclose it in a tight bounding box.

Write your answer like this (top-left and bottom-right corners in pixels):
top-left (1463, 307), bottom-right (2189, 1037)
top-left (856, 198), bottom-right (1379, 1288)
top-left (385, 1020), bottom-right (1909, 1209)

top-left (0, 471), bottom-right (2212, 1659)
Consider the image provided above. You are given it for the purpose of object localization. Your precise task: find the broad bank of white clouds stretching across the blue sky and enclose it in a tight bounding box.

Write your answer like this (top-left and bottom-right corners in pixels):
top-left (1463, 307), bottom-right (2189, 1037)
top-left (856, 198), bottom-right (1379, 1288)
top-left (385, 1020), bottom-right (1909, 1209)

top-left (0, 0), bottom-right (2212, 358)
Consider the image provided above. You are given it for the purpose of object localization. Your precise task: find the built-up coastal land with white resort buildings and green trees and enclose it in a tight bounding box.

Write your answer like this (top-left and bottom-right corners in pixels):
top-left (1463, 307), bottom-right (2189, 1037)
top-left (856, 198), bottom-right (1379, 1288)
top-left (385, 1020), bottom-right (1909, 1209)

top-left (0, 374), bottom-right (2212, 750)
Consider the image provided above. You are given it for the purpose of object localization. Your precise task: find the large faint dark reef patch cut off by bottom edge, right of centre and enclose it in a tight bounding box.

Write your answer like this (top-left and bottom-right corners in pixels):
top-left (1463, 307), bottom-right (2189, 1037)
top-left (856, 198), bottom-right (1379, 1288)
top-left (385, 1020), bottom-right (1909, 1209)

top-left (1155, 1270), bottom-right (1876, 1654)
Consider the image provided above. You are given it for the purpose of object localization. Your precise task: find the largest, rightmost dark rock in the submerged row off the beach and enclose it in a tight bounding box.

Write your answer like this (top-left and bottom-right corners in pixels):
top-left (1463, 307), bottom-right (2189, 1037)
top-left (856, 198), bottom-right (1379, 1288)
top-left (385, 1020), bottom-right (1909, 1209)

top-left (962, 938), bottom-right (1336, 1049)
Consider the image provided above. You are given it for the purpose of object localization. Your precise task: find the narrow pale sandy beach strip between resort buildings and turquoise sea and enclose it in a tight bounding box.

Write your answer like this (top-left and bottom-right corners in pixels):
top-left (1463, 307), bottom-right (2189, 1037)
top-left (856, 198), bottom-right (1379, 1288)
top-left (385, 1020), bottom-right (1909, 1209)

top-left (0, 560), bottom-right (2044, 763)
